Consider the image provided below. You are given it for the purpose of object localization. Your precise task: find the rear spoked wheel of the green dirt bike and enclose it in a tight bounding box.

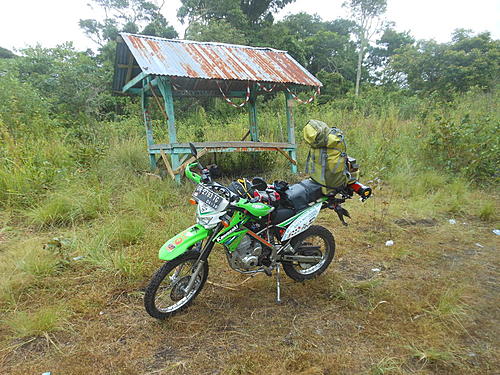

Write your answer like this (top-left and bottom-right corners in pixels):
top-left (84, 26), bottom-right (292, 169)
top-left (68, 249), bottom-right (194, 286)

top-left (283, 225), bottom-right (335, 281)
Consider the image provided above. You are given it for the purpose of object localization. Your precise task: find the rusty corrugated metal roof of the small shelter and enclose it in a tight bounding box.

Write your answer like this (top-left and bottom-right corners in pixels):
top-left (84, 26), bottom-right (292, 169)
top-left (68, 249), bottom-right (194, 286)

top-left (120, 33), bottom-right (322, 87)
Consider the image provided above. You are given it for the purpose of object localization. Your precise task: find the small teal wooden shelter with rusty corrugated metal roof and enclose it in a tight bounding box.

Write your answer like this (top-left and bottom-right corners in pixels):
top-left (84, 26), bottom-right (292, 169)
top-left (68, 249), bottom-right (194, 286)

top-left (113, 33), bottom-right (322, 181)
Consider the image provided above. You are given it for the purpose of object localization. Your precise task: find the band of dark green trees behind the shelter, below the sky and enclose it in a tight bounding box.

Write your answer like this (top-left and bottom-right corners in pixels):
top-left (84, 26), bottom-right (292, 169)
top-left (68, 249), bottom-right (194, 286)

top-left (0, 0), bottom-right (500, 129)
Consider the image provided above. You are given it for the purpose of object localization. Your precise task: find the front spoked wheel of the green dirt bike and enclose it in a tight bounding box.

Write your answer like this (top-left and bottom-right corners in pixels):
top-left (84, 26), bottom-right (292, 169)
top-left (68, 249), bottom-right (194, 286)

top-left (144, 251), bottom-right (208, 319)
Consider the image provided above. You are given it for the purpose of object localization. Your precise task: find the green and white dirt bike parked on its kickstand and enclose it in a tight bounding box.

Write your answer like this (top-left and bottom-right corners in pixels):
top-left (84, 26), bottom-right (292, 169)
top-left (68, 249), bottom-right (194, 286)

top-left (144, 145), bottom-right (371, 319)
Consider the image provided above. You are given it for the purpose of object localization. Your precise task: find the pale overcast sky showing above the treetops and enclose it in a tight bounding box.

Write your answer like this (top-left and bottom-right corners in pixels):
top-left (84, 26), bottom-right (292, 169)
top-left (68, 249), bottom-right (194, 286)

top-left (0, 0), bottom-right (500, 50)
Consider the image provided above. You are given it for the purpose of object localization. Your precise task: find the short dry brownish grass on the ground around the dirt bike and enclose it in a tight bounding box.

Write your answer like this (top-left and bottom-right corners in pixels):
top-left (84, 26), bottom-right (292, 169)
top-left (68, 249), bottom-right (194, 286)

top-left (0, 189), bottom-right (499, 375)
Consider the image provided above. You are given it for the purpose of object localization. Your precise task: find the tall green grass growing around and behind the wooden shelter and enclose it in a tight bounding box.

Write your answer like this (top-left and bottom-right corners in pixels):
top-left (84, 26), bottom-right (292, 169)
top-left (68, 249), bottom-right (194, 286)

top-left (0, 91), bottom-right (500, 212)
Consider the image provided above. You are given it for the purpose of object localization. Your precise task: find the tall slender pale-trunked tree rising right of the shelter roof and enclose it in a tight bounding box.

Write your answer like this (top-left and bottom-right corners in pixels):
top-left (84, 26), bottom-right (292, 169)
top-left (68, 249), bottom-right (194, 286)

top-left (343, 0), bottom-right (387, 96)
